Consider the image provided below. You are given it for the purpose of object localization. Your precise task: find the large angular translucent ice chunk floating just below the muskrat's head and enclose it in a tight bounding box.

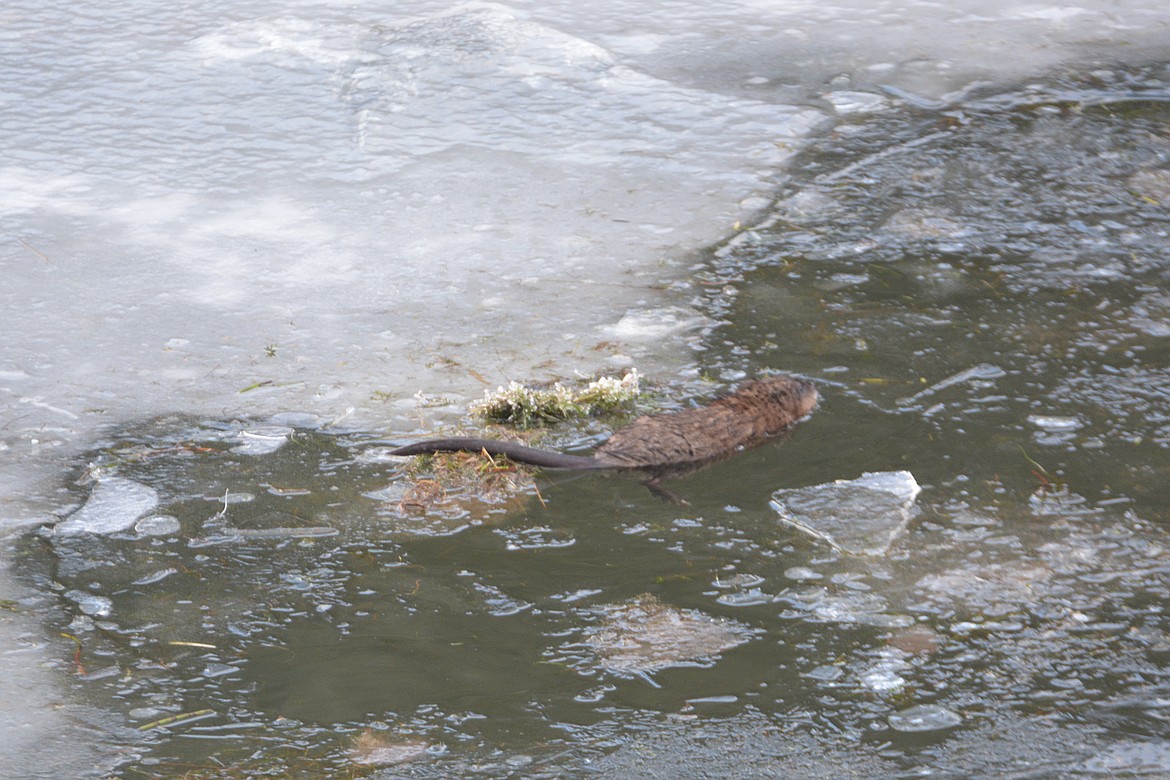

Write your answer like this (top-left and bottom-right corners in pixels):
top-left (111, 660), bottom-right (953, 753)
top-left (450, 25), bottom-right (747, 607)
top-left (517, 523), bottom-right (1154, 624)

top-left (772, 471), bottom-right (922, 555)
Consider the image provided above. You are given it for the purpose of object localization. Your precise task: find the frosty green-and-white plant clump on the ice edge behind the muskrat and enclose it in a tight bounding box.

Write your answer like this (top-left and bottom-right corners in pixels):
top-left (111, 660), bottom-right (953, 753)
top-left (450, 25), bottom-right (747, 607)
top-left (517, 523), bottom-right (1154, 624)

top-left (472, 371), bottom-right (640, 427)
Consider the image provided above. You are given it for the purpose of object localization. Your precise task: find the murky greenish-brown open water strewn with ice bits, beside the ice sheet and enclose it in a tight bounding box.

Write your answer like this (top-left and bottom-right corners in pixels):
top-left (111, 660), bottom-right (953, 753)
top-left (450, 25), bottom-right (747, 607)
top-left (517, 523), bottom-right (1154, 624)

top-left (16, 70), bottom-right (1170, 778)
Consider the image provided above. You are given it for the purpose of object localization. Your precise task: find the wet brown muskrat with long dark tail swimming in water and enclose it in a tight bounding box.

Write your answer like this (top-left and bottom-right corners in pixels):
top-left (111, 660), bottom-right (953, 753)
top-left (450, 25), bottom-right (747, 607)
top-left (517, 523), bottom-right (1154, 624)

top-left (391, 377), bottom-right (818, 501)
